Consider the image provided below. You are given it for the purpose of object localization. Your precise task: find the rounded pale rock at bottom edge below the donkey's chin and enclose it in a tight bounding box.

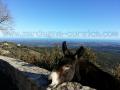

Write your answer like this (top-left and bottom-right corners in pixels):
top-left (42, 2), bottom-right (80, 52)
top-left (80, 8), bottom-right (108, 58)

top-left (47, 82), bottom-right (96, 90)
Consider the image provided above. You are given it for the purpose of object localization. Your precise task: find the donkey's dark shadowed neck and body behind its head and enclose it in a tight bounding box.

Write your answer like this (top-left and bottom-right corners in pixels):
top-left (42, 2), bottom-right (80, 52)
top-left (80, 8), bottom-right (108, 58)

top-left (74, 60), bottom-right (120, 90)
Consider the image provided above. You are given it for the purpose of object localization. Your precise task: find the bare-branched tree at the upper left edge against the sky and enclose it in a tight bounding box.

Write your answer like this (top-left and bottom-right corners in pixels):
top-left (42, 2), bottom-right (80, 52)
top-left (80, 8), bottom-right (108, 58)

top-left (0, 0), bottom-right (12, 32)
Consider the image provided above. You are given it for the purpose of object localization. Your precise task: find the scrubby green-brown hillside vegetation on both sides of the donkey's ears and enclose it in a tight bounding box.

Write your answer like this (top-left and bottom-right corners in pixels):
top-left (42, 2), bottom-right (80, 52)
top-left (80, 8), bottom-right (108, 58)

top-left (0, 42), bottom-right (120, 79)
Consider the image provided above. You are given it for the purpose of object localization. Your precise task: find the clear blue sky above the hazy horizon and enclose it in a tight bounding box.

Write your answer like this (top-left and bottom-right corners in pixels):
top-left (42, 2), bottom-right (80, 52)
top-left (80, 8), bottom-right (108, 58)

top-left (1, 0), bottom-right (120, 39)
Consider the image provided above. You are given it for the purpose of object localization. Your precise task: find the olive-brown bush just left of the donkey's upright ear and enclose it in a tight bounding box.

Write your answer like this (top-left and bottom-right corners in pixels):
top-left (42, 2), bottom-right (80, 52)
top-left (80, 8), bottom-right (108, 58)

top-left (34, 47), bottom-right (63, 70)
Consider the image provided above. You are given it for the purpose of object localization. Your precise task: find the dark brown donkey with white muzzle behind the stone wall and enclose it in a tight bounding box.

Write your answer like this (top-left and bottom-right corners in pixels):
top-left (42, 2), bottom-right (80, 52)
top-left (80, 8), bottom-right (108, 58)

top-left (49, 41), bottom-right (120, 90)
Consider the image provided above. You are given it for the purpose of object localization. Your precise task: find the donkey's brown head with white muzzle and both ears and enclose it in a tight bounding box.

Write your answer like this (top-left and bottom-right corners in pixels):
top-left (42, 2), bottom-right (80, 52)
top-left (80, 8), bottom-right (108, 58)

top-left (49, 41), bottom-right (84, 87)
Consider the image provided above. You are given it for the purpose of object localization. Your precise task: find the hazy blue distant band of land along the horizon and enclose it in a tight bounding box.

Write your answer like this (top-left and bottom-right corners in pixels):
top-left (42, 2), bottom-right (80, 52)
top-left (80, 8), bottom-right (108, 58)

top-left (0, 38), bottom-right (120, 47)
